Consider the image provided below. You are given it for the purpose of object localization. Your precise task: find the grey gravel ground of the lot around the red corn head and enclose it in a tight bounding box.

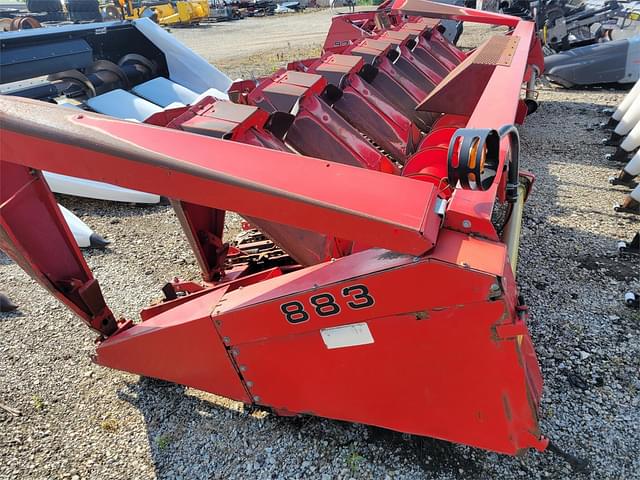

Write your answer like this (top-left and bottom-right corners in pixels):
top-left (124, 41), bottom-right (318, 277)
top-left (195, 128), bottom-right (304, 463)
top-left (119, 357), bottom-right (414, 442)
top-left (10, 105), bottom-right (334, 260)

top-left (0, 13), bottom-right (640, 480)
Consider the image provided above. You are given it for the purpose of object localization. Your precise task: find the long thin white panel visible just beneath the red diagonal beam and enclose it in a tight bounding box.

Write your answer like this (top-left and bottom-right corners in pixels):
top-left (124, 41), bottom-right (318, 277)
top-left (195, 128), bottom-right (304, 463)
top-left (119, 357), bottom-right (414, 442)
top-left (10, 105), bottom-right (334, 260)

top-left (43, 172), bottom-right (160, 203)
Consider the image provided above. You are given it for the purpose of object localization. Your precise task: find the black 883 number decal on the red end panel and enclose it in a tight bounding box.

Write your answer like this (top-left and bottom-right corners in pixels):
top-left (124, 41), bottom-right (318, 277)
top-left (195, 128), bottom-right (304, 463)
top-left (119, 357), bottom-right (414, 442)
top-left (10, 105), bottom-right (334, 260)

top-left (280, 284), bottom-right (375, 324)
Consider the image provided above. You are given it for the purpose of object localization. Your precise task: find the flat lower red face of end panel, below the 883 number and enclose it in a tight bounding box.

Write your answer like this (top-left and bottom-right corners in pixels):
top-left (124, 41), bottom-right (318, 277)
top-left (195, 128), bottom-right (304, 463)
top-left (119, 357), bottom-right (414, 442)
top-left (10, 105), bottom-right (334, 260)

top-left (234, 301), bottom-right (537, 454)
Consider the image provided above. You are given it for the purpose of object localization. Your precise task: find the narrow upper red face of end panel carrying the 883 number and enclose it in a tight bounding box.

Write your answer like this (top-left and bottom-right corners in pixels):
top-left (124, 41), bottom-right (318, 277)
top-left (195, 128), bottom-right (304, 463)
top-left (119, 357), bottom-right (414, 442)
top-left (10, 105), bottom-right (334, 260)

top-left (213, 246), bottom-right (505, 346)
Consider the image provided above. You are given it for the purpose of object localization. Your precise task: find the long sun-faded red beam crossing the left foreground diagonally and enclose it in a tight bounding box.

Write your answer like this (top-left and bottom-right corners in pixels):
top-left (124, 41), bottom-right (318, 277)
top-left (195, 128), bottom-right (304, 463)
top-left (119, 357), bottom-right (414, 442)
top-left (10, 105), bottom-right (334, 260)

top-left (0, 98), bottom-right (437, 254)
